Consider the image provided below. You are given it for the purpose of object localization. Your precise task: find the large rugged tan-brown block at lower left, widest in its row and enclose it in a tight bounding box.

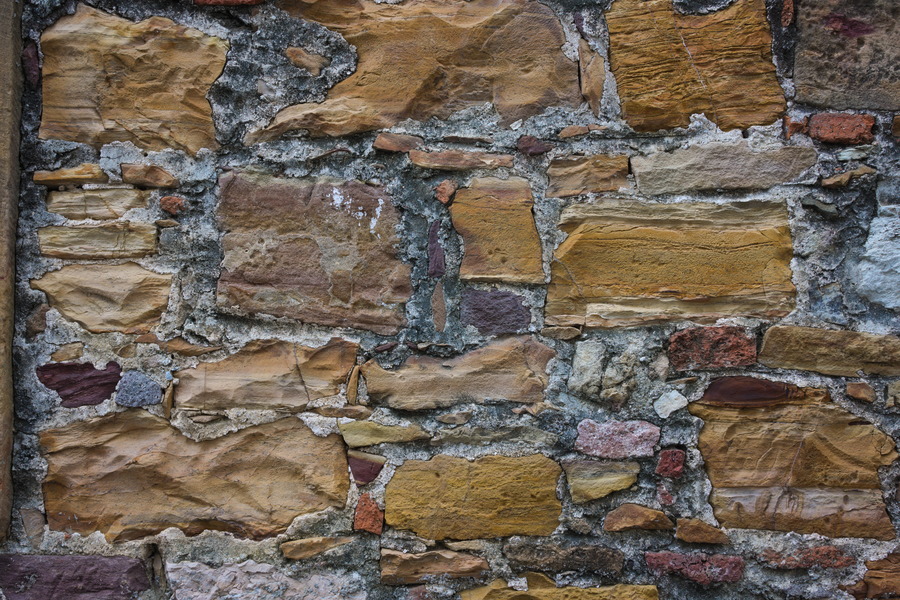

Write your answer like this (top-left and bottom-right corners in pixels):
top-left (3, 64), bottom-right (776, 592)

top-left (40, 410), bottom-right (350, 542)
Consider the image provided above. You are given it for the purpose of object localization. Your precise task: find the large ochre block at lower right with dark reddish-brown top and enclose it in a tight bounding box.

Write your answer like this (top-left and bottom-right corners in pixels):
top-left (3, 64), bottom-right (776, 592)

top-left (689, 377), bottom-right (897, 539)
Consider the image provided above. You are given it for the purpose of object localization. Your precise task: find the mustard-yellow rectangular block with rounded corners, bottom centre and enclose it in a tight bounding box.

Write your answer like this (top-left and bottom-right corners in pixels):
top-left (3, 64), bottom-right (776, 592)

top-left (385, 454), bottom-right (562, 540)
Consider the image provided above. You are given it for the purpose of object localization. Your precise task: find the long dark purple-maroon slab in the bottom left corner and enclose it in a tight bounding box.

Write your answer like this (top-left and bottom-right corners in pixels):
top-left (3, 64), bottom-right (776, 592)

top-left (0, 554), bottom-right (150, 600)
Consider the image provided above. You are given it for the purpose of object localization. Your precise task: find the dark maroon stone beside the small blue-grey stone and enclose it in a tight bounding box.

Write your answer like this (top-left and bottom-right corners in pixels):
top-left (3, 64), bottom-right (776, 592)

top-left (37, 362), bottom-right (122, 408)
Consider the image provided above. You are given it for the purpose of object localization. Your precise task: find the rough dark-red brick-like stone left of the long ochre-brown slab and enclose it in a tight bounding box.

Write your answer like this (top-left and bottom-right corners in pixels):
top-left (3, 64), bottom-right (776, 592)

top-left (669, 326), bottom-right (756, 371)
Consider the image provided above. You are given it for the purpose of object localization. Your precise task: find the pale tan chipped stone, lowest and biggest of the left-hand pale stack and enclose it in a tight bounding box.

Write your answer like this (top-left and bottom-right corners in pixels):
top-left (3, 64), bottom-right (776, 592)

top-left (31, 262), bottom-right (172, 333)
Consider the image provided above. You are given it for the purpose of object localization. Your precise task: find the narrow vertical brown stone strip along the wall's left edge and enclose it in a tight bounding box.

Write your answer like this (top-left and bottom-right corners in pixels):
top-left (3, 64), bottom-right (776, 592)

top-left (0, 1), bottom-right (22, 541)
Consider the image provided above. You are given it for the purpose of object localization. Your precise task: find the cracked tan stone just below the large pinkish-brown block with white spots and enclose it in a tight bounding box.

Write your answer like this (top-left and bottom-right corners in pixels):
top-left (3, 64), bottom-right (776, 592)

top-left (175, 339), bottom-right (359, 411)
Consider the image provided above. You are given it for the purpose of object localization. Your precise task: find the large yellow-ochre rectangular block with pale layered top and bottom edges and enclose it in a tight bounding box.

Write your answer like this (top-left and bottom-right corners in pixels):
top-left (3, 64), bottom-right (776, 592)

top-left (545, 200), bottom-right (795, 327)
